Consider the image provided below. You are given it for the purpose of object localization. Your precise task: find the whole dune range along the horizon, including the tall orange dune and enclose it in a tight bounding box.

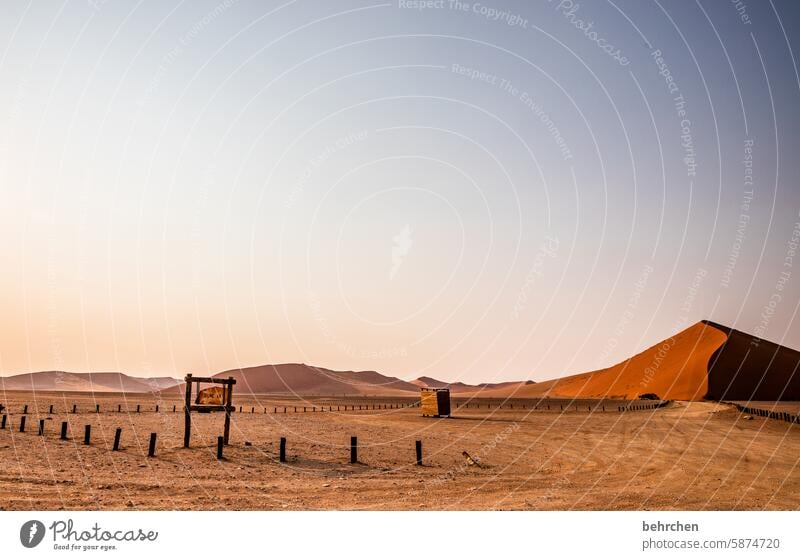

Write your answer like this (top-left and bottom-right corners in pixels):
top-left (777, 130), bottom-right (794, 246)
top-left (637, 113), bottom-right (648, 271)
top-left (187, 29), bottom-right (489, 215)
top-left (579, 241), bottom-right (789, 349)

top-left (0, 321), bottom-right (800, 401)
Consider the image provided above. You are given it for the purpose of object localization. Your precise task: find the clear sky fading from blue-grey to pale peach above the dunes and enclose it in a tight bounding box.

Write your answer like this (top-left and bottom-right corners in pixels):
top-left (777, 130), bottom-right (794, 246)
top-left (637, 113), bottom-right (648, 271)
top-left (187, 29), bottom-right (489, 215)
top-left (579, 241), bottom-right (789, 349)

top-left (0, 0), bottom-right (800, 382)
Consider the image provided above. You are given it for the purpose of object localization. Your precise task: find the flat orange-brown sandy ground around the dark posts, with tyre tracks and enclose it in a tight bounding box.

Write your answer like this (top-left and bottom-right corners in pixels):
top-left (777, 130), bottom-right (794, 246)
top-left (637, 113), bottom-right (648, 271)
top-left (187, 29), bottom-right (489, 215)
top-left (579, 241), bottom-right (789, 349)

top-left (0, 393), bottom-right (800, 510)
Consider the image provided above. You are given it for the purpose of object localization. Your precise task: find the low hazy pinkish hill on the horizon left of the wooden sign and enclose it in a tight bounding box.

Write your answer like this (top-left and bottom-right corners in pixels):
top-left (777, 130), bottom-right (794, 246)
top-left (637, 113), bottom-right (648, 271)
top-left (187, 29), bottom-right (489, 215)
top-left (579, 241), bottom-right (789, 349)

top-left (0, 371), bottom-right (178, 393)
